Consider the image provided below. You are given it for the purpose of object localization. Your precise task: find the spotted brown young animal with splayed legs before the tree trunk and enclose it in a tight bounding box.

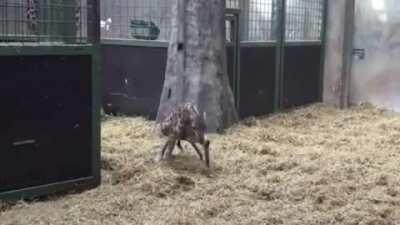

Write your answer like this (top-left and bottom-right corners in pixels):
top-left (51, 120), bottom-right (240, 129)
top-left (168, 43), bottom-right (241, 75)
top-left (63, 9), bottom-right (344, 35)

top-left (161, 103), bottom-right (210, 167)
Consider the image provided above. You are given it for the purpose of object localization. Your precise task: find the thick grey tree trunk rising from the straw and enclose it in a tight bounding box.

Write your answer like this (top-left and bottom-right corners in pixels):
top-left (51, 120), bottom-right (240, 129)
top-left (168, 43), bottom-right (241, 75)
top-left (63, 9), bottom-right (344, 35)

top-left (157, 0), bottom-right (238, 132)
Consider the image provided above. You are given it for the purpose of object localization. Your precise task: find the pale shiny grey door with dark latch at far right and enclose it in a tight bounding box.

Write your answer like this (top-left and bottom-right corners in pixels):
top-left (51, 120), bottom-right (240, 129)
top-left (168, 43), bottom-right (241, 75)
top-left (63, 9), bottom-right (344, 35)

top-left (349, 0), bottom-right (400, 112)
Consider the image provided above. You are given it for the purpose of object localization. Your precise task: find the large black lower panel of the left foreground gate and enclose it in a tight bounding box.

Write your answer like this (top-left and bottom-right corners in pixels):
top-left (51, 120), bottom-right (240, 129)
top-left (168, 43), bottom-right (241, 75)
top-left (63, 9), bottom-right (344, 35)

top-left (0, 56), bottom-right (95, 193)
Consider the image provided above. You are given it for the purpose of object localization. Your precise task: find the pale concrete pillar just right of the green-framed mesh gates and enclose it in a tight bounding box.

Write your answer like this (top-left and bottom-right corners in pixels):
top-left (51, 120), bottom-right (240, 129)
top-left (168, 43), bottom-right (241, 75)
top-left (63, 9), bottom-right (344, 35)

top-left (323, 0), bottom-right (346, 106)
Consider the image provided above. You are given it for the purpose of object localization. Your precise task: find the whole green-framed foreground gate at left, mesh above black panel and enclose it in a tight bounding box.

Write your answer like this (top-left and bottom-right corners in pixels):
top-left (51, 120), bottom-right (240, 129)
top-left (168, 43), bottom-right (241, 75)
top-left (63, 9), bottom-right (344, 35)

top-left (0, 0), bottom-right (101, 198)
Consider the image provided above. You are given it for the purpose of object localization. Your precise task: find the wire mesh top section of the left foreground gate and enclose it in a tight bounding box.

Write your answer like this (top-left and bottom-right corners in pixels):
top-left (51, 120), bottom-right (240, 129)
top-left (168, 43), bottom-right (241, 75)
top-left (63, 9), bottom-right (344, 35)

top-left (0, 0), bottom-right (92, 44)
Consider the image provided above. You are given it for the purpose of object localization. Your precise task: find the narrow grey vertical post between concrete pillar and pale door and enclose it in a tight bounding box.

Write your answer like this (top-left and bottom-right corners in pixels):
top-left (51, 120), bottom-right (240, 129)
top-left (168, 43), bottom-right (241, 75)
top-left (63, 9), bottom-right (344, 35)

top-left (340, 0), bottom-right (355, 109)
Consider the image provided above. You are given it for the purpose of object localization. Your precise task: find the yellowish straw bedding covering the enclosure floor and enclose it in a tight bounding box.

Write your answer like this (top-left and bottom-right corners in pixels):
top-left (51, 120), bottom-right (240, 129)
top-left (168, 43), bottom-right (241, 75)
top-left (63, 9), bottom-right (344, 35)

top-left (0, 104), bottom-right (400, 225)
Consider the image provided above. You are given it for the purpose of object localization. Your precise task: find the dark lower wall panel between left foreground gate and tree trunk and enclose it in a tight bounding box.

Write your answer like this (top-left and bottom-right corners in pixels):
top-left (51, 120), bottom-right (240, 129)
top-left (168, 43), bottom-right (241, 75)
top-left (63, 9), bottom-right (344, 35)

top-left (101, 45), bottom-right (167, 118)
